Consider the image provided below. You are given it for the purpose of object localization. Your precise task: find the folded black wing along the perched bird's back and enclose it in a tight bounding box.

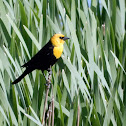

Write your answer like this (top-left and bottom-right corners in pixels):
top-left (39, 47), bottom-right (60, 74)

top-left (22, 41), bottom-right (53, 67)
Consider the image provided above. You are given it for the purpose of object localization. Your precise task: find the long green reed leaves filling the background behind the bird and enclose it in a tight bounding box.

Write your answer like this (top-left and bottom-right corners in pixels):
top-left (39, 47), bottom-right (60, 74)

top-left (0, 0), bottom-right (126, 126)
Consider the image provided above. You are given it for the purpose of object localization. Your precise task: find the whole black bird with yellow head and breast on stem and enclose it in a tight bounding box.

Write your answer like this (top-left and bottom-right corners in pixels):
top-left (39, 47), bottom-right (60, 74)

top-left (12, 34), bottom-right (69, 84)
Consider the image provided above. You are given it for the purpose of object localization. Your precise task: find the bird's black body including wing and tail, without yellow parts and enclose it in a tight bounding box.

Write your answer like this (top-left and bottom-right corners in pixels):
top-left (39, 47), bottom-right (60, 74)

top-left (12, 41), bottom-right (57, 84)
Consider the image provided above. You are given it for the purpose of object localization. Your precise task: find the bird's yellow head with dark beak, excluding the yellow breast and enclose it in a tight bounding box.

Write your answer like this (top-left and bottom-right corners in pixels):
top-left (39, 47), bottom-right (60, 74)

top-left (50, 34), bottom-right (69, 47)
